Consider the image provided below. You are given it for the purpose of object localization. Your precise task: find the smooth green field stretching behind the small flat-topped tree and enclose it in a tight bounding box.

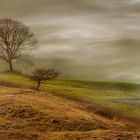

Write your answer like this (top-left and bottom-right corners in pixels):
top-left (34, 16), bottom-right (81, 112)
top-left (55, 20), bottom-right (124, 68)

top-left (0, 72), bottom-right (140, 118)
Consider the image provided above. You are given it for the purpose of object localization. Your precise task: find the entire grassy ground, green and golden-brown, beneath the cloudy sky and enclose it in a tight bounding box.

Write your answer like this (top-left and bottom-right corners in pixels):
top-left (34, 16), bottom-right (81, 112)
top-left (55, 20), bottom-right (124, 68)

top-left (0, 72), bottom-right (140, 140)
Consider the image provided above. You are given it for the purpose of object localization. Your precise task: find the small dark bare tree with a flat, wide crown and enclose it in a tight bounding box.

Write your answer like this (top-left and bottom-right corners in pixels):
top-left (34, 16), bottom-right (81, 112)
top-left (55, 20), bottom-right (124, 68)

top-left (30, 69), bottom-right (59, 90)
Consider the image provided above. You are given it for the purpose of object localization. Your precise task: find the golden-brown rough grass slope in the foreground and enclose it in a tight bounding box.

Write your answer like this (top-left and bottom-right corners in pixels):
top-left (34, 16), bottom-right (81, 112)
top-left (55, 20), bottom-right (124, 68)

top-left (0, 86), bottom-right (140, 140)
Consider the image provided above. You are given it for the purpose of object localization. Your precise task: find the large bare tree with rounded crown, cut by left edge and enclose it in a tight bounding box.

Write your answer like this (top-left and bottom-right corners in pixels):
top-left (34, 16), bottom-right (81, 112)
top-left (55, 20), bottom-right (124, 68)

top-left (0, 19), bottom-right (37, 71)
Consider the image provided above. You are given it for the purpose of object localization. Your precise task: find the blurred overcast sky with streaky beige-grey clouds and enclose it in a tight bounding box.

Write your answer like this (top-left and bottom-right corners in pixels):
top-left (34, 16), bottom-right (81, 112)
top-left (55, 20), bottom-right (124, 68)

top-left (0, 0), bottom-right (140, 83)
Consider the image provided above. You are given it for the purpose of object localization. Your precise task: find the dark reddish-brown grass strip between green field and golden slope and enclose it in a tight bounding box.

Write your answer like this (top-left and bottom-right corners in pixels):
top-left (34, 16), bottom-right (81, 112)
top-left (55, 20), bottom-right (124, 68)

top-left (51, 91), bottom-right (140, 131)
